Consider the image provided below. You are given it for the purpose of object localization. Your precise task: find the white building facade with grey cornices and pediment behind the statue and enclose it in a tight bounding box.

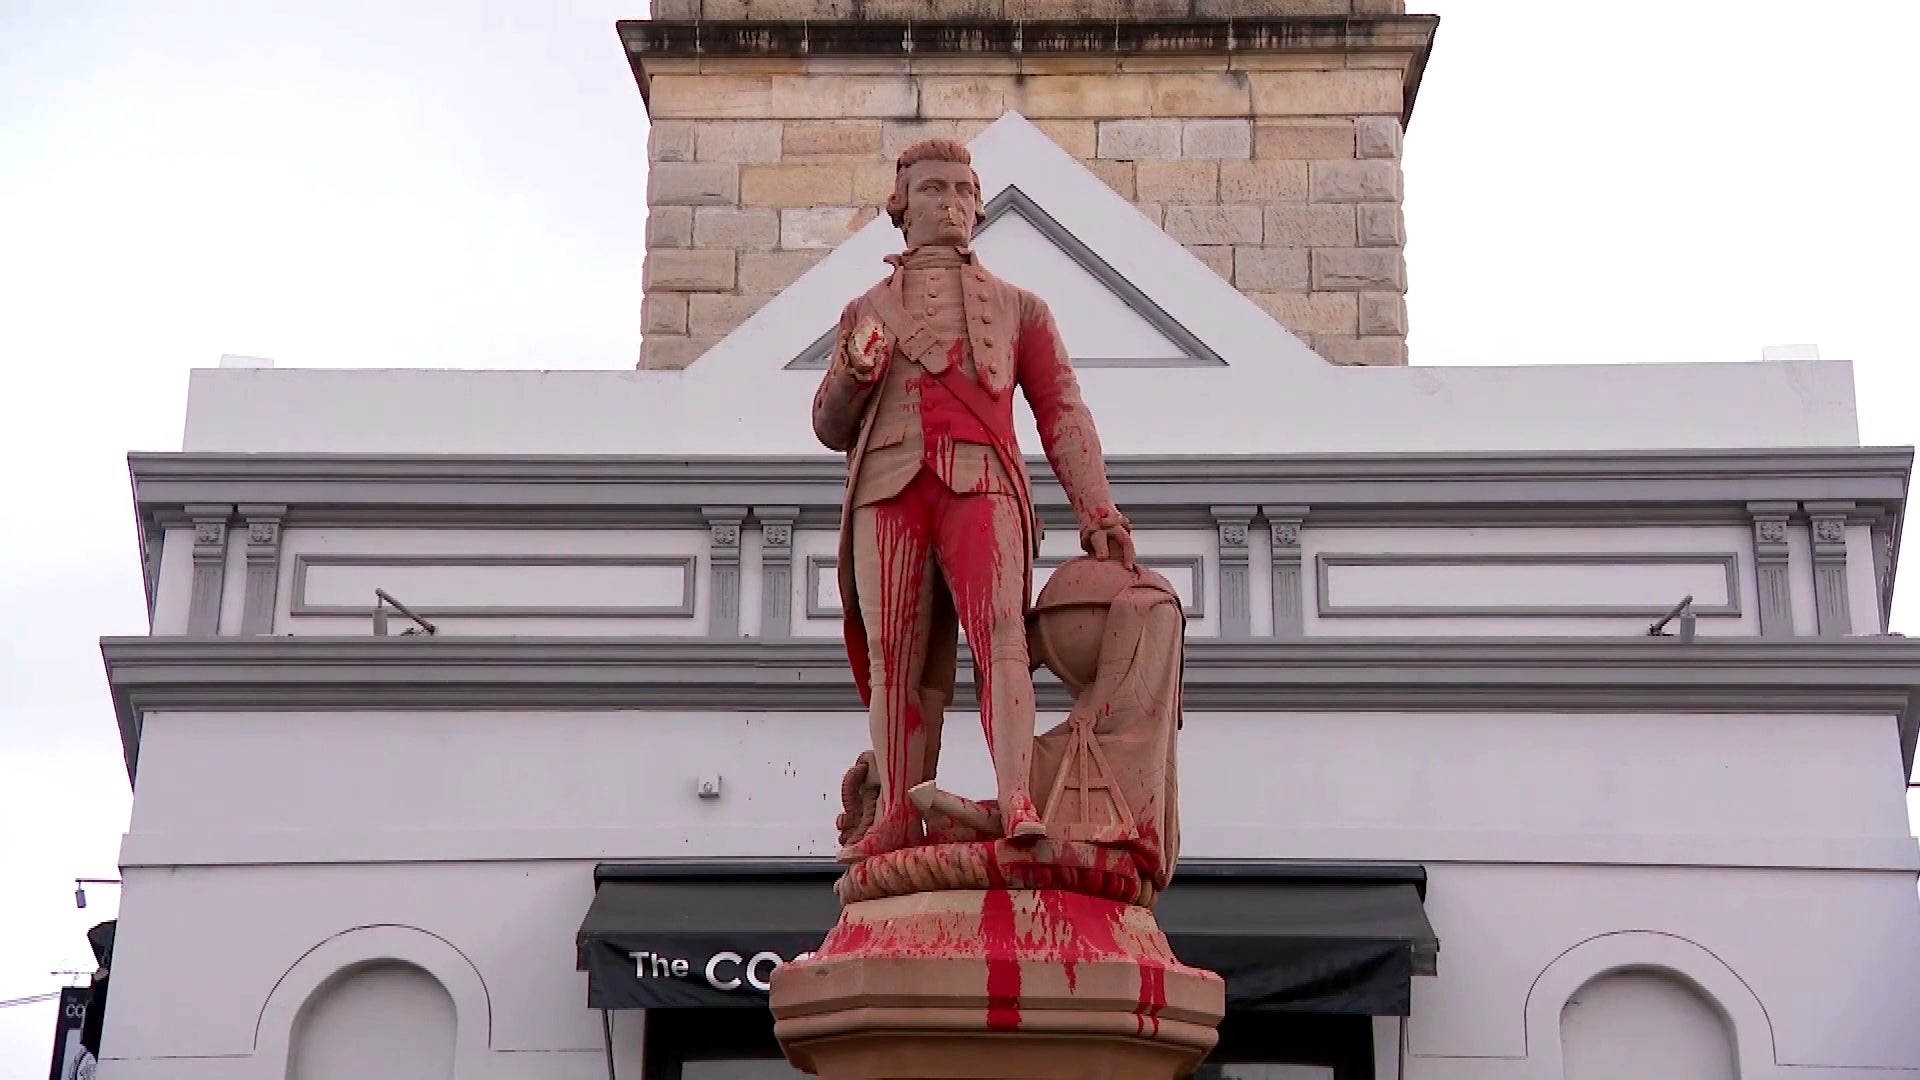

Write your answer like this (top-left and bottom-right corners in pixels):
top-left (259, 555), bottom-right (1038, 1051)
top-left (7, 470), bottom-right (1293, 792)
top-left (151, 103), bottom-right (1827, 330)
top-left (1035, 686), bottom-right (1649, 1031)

top-left (102, 92), bottom-right (1920, 1080)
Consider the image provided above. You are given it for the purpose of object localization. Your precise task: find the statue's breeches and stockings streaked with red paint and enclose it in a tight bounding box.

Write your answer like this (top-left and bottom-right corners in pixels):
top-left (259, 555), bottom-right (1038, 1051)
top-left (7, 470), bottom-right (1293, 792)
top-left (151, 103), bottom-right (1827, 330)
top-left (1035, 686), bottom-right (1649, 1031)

top-left (852, 471), bottom-right (1033, 821)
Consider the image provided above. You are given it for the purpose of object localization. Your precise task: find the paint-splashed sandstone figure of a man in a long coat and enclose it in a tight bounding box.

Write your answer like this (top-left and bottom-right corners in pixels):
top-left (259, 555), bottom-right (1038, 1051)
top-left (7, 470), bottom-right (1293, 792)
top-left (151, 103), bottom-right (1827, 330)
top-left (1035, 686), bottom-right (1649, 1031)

top-left (814, 138), bottom-right (1133, 863)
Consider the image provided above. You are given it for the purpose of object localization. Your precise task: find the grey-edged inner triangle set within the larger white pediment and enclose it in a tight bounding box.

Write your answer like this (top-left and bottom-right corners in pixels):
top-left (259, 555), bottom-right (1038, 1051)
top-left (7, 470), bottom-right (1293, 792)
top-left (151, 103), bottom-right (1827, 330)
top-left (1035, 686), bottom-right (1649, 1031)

top-left (787, 184), bottom-right (1225, 371)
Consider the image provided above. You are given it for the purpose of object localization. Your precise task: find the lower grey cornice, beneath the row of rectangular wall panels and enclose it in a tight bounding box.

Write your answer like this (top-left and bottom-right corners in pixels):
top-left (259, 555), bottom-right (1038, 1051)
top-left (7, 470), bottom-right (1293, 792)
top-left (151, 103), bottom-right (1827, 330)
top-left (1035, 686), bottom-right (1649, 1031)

top-left (102, 636), bottom-right (1920, 774)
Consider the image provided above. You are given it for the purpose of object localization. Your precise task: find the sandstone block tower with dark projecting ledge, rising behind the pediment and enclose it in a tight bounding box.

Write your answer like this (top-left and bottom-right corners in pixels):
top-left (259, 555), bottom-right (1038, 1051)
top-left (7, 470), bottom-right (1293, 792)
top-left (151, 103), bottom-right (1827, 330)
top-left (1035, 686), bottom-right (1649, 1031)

top-left (620, 0), bottom-right (1438, 369)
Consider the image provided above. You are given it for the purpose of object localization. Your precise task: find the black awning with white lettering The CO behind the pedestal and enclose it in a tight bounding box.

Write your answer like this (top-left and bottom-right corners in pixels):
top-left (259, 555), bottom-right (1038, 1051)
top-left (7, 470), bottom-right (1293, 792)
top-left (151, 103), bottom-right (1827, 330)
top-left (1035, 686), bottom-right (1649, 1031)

top-left (576, 863), bottom-right (1438, 1017)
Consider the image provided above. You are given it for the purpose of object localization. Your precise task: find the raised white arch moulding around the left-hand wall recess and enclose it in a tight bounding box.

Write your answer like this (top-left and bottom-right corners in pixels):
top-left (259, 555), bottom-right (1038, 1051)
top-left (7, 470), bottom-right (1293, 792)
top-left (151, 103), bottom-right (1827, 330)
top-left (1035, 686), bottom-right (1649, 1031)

top-left (253, 924), bottom-right (493, 1080)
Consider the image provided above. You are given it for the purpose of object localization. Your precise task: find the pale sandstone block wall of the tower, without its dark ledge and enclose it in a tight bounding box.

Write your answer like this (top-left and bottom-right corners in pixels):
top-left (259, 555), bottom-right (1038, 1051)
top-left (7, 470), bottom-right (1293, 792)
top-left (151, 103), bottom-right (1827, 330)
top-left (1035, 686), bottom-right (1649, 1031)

top-left (641, 0), bottom-right (1415, 369)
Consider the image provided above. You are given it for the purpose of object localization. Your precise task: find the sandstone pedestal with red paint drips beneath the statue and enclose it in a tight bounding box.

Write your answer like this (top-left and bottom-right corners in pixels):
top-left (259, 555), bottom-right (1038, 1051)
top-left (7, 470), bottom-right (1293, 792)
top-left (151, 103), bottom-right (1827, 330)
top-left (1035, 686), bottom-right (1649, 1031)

top-left (772, 888), bottom-right (1225, 1080)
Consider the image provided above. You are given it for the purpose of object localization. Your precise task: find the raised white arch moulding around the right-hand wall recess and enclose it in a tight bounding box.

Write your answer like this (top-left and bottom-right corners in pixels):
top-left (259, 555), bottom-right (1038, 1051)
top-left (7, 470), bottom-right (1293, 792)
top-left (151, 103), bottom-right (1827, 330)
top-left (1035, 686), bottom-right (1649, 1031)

top-left (1526, 930), bottom-right (1776, 1080)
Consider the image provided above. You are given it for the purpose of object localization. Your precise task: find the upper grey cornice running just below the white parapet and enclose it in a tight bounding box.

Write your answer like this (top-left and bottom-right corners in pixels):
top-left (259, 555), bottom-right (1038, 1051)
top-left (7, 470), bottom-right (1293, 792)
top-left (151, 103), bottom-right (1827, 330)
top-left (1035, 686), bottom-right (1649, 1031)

top-left (129, 448), bottom-right (1914, 528)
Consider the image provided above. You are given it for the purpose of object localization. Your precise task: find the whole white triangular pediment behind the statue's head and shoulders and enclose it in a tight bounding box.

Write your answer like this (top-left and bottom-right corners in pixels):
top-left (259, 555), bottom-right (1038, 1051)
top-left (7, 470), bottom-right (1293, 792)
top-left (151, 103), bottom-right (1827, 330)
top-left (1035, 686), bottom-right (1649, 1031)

top-left (682, 111), bottom-right (1327, 382)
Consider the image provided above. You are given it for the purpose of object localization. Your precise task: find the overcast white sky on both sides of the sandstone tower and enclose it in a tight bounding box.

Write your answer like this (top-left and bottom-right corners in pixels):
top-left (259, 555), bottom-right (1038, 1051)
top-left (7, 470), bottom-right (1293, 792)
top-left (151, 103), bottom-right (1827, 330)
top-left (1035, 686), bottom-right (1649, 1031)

top-left (0, 0), bottom-right (1920, 1076)
